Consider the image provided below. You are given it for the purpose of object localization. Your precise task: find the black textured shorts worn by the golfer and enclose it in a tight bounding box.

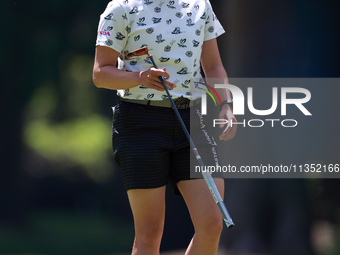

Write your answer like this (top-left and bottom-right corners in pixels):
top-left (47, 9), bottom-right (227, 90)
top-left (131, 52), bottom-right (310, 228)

top-left (112, 101), bottom-right (217, 195)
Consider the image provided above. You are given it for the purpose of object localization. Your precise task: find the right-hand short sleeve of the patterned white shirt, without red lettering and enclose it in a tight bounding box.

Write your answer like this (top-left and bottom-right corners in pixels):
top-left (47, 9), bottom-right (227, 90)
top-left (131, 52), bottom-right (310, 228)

top-left (204, 1), bottom-right (225, 41)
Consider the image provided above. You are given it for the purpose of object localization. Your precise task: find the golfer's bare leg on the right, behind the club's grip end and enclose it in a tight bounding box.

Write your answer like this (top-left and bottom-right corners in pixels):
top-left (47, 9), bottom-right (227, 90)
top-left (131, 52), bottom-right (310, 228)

top-left (177, 179), bottom-right (224, 255)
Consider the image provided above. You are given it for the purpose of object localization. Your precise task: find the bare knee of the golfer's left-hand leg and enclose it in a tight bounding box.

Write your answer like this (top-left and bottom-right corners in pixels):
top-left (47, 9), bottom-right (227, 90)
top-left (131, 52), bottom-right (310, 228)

top-left (136, 224), bottom-right (163, 247)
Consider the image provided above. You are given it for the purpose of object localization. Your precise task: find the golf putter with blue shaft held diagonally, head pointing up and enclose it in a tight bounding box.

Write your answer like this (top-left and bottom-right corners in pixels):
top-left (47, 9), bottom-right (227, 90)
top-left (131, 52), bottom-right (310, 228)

top-left (125, 47), bottom-right (235, 229)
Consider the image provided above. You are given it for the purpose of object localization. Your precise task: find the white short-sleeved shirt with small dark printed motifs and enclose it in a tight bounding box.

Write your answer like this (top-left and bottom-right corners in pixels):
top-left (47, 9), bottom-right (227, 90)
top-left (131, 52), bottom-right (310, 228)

top-left (96, 0), bottom-right (224, 100)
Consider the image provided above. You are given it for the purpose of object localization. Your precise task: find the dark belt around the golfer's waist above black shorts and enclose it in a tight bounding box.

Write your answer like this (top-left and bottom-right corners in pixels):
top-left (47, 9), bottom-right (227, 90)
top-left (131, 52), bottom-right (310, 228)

top-left (120, 97), bottom-right (201, 109)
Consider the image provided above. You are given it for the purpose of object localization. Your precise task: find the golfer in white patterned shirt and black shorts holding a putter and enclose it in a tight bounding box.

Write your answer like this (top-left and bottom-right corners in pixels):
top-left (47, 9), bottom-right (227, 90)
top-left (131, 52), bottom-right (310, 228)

top-left (93, 0), bottom-right (237, 255)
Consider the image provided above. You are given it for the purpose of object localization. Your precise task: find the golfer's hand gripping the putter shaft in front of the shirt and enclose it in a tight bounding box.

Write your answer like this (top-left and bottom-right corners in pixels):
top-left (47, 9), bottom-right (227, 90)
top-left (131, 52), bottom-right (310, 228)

top-left (139, 67), bottom-right (176, 91)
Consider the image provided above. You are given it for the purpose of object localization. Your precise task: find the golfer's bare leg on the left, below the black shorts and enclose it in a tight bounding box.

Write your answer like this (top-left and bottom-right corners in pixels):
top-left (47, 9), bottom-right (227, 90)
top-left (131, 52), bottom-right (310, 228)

top-left (128, 186), bottom-right (165, 255)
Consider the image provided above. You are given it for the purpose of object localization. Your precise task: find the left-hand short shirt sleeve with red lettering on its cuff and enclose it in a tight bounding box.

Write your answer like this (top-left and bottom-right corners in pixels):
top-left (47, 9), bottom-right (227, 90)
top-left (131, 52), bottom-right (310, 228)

top-left (96, 1), bottom-right (128, 52)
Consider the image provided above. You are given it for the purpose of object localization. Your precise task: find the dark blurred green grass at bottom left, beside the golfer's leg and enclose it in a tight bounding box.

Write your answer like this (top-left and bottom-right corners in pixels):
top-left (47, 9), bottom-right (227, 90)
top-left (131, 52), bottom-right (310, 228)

top-left (0, 210), bottom-right (134, 255)
